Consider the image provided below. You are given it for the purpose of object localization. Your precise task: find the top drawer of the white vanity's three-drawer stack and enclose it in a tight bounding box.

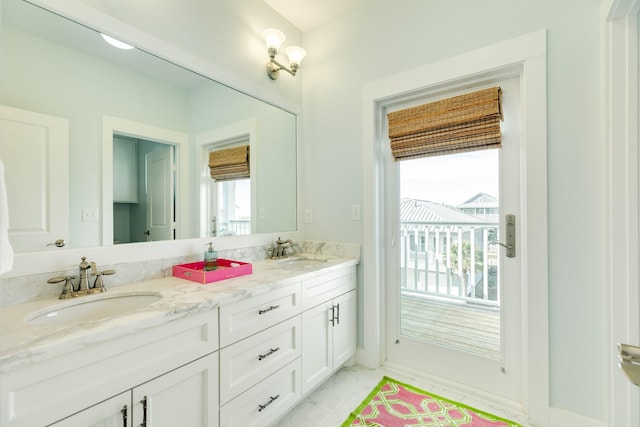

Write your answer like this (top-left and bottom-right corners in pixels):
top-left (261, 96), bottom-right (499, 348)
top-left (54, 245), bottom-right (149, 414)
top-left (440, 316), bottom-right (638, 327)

top-left (220, 283), bottom-right (301, 348)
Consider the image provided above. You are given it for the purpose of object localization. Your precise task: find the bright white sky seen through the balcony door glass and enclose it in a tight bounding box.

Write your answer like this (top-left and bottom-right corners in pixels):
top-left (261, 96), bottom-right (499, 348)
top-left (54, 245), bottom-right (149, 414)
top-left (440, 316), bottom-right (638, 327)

top-left (400, 149), bottom-right (500, 206)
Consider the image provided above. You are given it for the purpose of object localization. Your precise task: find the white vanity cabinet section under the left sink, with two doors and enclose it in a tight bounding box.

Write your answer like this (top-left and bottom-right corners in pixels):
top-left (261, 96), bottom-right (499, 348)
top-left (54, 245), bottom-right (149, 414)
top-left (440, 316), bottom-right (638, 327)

top-left (0, 309), bottom-right (218, 427)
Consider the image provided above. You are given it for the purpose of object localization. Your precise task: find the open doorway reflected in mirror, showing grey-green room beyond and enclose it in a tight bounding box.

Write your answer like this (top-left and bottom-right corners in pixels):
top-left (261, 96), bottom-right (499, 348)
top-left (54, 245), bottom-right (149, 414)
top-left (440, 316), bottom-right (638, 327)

top-left (113, 135), bottom-right (176, 244)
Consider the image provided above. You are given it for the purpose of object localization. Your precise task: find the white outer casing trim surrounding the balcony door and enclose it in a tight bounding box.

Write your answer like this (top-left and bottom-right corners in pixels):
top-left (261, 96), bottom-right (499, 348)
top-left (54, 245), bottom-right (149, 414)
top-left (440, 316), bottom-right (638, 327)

top-left (357, 30), bottom-right (549, 426)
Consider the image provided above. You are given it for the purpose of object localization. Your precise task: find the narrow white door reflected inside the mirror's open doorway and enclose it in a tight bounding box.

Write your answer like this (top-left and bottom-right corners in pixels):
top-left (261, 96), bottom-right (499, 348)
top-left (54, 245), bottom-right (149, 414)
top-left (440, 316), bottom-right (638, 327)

top-left (145, 146), bottom-right (175, 242)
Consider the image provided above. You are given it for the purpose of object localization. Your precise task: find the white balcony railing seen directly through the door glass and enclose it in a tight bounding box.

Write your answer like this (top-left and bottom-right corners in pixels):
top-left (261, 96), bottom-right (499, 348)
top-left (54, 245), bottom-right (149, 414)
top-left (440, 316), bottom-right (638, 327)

top-left (400, 222), bottom-right (500, 306)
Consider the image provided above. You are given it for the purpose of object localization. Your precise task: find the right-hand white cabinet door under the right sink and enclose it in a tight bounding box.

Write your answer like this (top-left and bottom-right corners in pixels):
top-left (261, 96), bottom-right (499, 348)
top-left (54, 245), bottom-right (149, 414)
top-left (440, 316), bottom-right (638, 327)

top-left (333, 291), bottom-right (357, 370)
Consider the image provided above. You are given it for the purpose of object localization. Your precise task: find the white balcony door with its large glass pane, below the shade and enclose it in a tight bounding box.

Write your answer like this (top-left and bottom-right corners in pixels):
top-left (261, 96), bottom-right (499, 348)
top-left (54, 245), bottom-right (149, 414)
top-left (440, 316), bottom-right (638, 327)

top-left (385, 78), bottom-right (524, 402)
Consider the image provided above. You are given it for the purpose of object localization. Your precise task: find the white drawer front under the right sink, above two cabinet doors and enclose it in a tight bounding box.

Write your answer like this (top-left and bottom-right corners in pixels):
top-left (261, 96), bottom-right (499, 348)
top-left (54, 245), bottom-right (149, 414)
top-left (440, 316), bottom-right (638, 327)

top-left (302, 266), bottom-right (356, 310)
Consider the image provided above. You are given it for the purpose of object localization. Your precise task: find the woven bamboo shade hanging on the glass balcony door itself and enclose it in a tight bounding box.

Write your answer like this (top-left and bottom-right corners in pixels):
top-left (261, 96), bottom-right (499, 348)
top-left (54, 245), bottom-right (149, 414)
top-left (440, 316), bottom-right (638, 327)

top-left (387, 87), bottom-right (502, 160)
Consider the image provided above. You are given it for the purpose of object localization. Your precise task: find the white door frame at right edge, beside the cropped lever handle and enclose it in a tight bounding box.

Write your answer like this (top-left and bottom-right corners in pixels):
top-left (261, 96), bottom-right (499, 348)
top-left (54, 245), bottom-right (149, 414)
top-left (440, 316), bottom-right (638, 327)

top-left (602, 0), bottom-right (640, 426)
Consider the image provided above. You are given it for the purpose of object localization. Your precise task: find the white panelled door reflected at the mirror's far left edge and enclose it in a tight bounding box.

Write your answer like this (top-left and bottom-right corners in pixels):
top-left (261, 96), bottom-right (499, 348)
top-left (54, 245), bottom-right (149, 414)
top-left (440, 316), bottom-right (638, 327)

top-left (0, 106), bottom-right (69, 253)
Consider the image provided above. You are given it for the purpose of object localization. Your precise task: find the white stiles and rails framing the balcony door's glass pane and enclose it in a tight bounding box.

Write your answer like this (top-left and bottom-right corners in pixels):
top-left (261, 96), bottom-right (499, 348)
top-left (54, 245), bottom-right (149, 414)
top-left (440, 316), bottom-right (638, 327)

top-left (380, 77), bottom-right (525, 404)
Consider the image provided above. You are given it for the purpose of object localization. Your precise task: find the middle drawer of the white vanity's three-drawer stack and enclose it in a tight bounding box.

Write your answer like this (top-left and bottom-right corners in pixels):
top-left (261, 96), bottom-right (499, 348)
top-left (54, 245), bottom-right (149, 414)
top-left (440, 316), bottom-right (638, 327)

top-left (220, 316), bottom-right (301, 404)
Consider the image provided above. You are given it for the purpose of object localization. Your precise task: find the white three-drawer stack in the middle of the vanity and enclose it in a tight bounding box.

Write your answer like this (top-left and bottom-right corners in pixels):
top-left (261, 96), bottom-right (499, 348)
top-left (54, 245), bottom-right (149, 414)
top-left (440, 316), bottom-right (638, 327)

top-left (220, 282), bottom-right (302, 427)
